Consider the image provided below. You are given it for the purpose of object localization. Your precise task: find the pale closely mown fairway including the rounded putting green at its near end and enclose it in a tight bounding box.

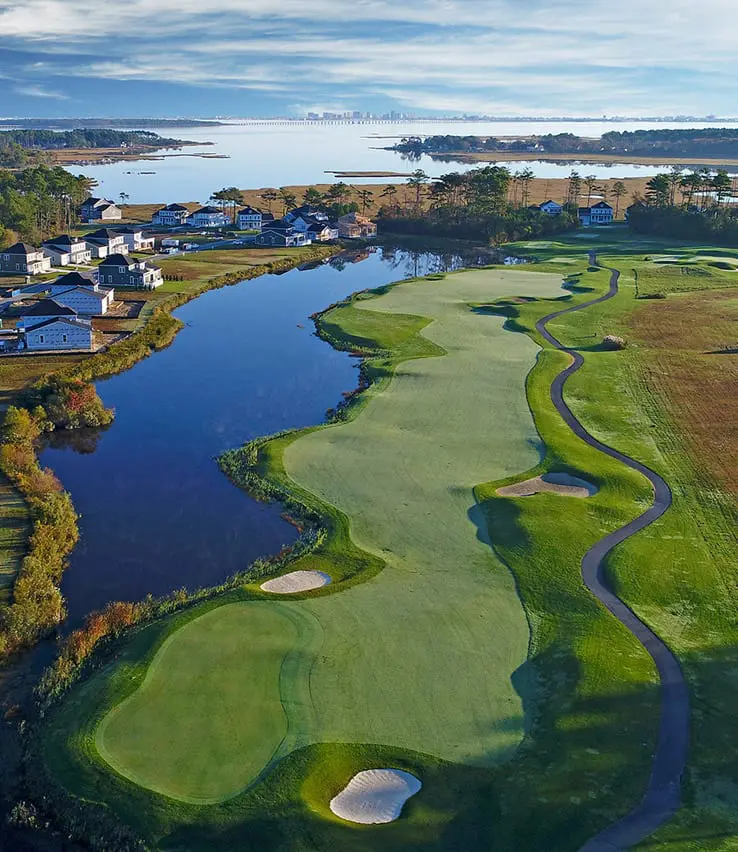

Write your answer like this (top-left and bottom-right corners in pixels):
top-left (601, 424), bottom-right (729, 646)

top-left (98, 270), bottom-right (561, 801)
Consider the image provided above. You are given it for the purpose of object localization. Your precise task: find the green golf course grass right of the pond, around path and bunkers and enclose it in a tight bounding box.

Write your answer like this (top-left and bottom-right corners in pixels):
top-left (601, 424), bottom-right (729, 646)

top-left (40, 228), bottom-right (738, 852)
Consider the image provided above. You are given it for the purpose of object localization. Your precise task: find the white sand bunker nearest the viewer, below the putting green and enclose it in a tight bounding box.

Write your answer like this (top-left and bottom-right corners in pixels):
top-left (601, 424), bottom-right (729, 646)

top-left (330, 769), bottom-right (423, 825)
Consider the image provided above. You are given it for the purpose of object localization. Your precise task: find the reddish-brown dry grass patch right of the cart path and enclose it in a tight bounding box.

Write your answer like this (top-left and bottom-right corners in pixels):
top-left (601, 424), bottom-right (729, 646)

top-left (630, 290), bottom-right (738, 499)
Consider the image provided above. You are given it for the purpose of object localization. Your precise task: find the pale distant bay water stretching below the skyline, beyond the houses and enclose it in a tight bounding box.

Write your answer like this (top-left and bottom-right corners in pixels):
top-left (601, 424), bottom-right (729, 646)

top-left (76, 122), bottom-right (732, 204)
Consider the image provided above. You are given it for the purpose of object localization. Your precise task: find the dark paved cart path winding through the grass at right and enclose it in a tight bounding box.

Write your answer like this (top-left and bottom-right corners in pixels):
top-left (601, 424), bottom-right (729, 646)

top-left (536, 254), bottom-right (689, 852)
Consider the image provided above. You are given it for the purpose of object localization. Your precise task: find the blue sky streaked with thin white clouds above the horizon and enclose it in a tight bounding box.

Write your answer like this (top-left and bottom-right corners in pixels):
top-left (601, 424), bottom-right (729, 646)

top-left (0, 0), bottom-right (738, 117)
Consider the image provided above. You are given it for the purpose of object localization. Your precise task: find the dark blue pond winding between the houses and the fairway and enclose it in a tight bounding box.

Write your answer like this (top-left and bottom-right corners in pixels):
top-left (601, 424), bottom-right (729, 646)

top-left (41, 241), bottom-right (488, 626)
